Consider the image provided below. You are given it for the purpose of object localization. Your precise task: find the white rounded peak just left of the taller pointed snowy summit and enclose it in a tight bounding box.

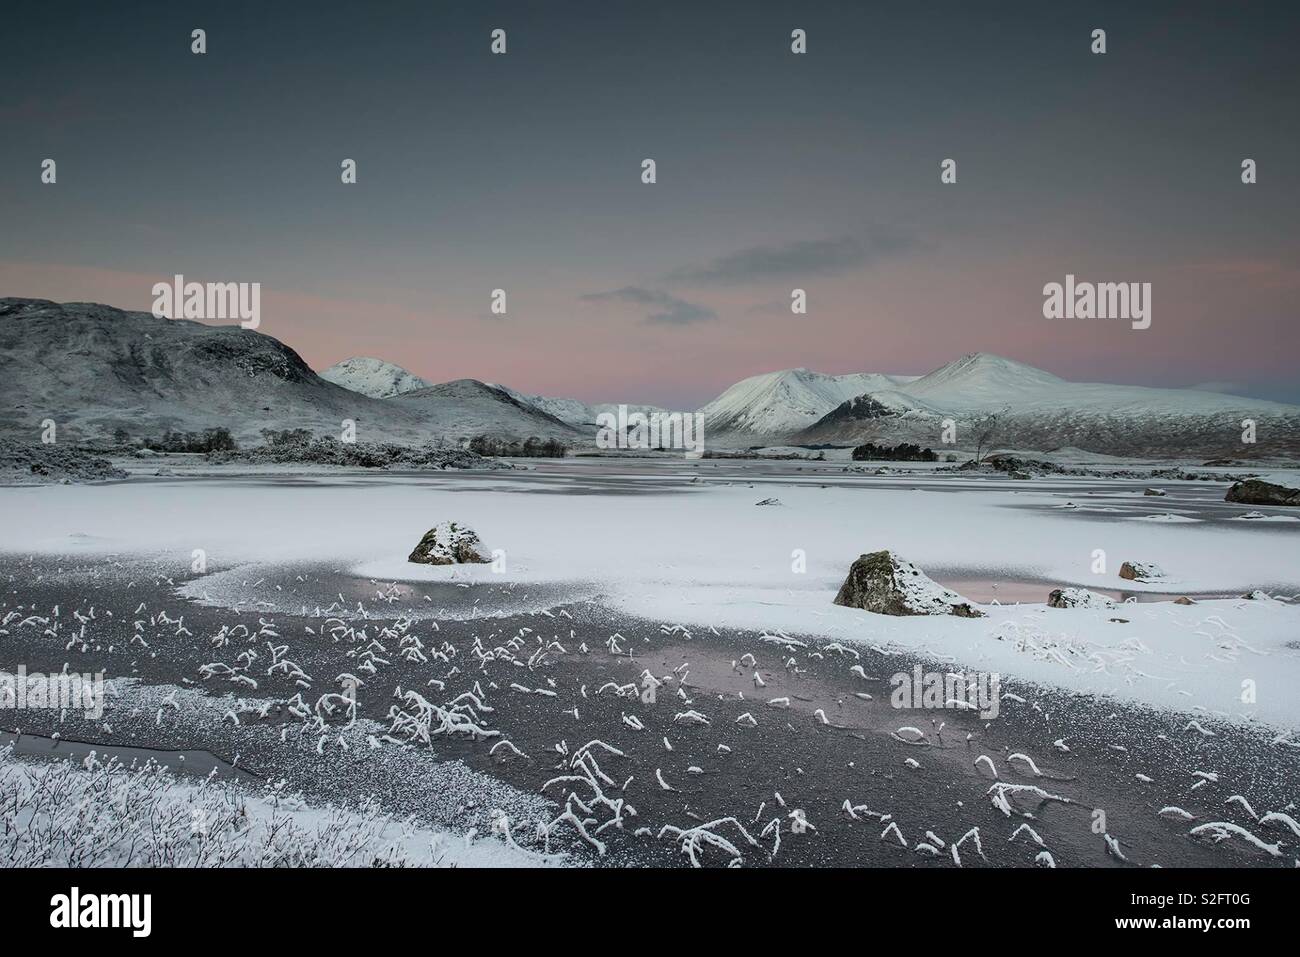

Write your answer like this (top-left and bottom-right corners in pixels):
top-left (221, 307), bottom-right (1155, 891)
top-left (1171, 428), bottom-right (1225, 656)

top-left (699, 369), bottom-right (913, 436)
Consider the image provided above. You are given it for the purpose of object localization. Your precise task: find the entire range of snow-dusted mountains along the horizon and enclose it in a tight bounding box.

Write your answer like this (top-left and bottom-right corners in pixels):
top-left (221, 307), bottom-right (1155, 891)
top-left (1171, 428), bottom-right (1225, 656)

top-left (0, 299), bottom-right (1300, 458)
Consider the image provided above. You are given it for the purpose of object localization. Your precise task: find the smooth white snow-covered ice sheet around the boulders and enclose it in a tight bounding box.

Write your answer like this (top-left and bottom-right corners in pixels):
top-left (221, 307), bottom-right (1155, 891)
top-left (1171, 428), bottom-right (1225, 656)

top-left (0, 464), bottom-right (1300, 728)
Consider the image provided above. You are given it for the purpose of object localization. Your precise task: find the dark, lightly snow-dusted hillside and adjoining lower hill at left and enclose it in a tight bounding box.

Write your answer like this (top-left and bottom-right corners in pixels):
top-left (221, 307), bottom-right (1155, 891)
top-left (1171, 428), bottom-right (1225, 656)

top-left (0, 299), bottom-right (584, 445)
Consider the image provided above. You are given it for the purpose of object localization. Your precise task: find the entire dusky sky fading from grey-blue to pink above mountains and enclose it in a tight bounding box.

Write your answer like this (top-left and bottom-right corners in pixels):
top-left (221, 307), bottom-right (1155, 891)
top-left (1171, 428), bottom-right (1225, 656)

top-left (0, 0), bottom-right (1300, 406)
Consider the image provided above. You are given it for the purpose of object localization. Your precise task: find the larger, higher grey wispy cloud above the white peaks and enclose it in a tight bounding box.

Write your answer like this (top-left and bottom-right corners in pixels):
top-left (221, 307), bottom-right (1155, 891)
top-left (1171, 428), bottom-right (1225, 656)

top-left (668, 226), bottom-right (922, 285)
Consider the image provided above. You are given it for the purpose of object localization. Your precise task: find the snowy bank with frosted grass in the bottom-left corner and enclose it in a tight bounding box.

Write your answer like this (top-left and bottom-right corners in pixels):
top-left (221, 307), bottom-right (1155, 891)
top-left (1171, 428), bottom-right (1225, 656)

top-left (0, 745), bottom-right (546, 867)
